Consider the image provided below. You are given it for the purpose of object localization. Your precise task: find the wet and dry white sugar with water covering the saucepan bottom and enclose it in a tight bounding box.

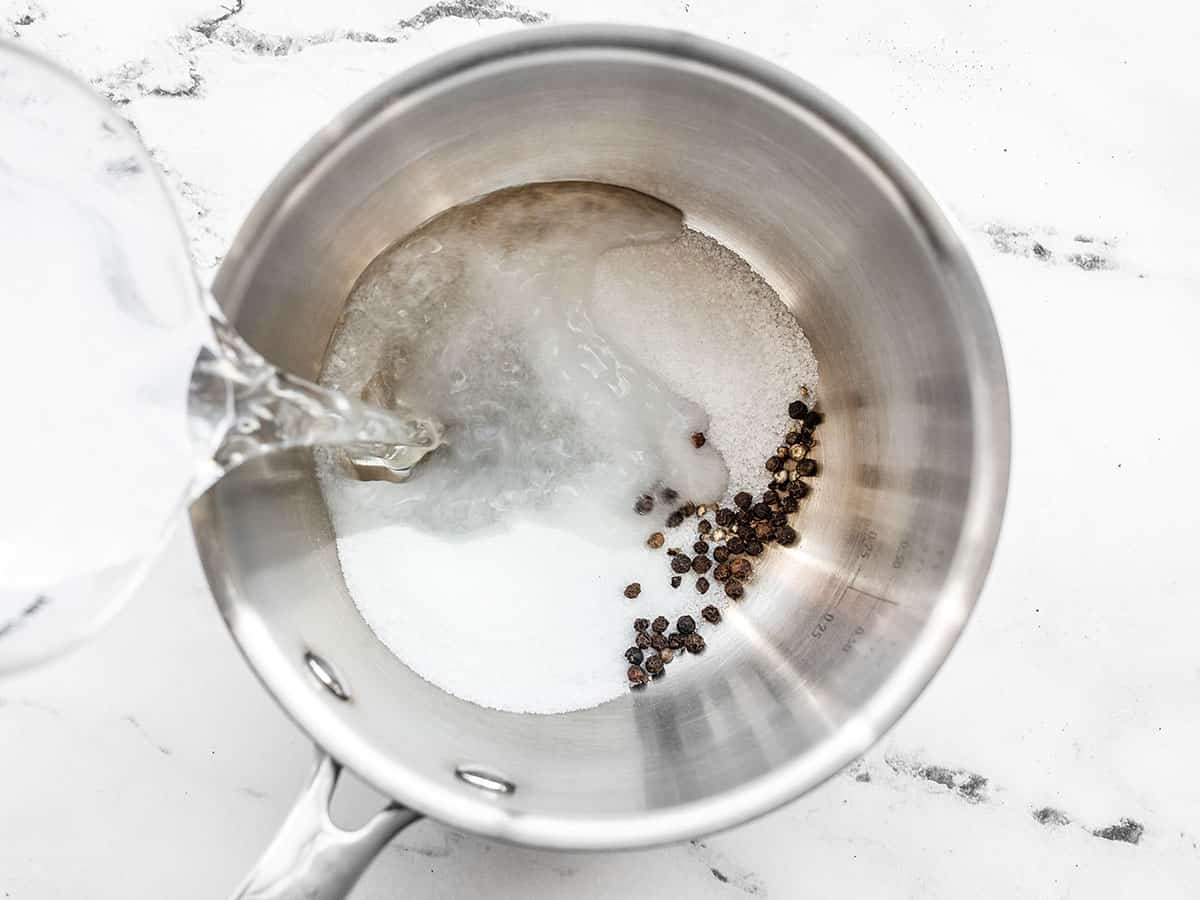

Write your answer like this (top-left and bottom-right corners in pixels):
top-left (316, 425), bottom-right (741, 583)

top-left (319, 184), bottom-right (816, 713)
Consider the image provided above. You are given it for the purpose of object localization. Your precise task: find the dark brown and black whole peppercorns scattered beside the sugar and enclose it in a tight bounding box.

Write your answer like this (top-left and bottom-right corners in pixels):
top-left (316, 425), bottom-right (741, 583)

top-left (625, 398), bottom-right (823, 688)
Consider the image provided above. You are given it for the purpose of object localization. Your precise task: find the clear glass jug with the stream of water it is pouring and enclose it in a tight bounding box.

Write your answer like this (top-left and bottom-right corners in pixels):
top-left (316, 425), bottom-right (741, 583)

top-left (0, 42), bottom-right (440, 672)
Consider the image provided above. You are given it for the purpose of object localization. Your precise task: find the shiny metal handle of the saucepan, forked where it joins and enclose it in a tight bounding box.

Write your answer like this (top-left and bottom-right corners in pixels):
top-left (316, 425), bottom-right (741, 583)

top-left (234, 750), bottom-right (421, 900)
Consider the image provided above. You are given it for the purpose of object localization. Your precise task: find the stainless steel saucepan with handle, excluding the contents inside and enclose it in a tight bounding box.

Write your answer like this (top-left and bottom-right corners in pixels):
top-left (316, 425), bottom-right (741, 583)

top-left (193, 28), bottom-right (1009, 899)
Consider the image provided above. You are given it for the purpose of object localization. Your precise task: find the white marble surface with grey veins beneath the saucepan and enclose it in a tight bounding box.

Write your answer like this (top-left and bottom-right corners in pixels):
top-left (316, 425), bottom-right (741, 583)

top-left (0, 0), bottom-right (1200, 900)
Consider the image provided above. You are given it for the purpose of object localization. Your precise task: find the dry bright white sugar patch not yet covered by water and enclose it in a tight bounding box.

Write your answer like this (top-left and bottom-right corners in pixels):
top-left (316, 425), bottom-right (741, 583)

top-left (321, 482), bottom-right (714, 713)
